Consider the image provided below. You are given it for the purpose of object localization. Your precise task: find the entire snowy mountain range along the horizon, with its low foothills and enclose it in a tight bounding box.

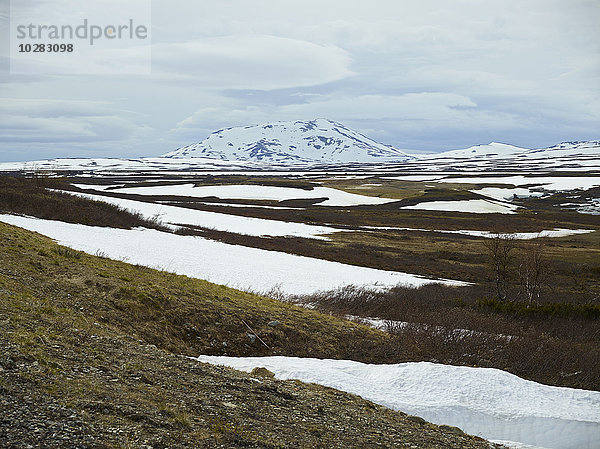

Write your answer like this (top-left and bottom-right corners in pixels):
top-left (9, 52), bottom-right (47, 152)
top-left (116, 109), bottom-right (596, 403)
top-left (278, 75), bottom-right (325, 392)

top-left (0, 136), bottom-right (600, 173)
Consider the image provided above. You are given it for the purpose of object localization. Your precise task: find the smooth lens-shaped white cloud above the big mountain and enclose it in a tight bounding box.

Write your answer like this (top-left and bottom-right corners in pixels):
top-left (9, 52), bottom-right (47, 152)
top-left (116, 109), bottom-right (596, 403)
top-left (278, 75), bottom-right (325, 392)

top-left (152, 35), bottom-right (353, 90)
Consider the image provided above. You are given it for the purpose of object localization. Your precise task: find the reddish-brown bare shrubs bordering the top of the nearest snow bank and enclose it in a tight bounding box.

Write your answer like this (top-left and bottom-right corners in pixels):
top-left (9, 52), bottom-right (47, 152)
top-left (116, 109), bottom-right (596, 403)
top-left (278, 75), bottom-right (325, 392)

top-left (290, 284), bottom-right (600, 390)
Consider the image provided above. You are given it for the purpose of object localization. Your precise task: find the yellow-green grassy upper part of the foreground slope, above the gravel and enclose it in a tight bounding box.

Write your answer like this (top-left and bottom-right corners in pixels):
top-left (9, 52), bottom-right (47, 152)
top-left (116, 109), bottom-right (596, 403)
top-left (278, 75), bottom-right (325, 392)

top-left (0, 223), bottom-right (387, 360)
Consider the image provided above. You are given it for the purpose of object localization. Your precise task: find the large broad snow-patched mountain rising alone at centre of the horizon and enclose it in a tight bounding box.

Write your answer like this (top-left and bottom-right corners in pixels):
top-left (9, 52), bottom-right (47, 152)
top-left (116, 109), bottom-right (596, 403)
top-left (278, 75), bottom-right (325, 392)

top-left (163, 119), bottom-right (416, 163)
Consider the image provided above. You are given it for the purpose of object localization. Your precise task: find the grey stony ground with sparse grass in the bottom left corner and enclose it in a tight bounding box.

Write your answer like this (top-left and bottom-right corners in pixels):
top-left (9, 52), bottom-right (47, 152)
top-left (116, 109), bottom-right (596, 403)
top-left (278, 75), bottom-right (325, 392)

top-left (0, 322), bottom-right (502, 449)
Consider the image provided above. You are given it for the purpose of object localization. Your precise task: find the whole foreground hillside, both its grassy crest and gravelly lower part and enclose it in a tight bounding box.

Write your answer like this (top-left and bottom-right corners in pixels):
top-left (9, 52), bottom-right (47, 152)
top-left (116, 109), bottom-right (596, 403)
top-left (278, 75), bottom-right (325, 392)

top-left (0, 224), bottom-right (502, 449)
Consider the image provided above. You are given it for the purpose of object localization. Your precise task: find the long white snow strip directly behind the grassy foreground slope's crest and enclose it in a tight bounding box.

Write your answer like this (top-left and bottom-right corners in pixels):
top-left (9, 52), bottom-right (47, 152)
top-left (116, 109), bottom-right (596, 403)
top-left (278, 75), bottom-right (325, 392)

top-left (0, 215), bottom-right (464, 294)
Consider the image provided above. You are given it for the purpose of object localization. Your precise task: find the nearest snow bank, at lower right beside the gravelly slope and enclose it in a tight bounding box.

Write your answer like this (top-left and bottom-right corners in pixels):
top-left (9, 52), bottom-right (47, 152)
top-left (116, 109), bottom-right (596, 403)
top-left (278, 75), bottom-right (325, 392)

top-left (198, 356), bottom-right (600, 449)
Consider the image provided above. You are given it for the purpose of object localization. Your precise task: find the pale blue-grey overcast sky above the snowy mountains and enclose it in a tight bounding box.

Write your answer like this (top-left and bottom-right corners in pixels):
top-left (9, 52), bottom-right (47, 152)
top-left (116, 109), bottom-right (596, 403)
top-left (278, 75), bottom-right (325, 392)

top-left (0, 0), bottom-right (600, 161)
